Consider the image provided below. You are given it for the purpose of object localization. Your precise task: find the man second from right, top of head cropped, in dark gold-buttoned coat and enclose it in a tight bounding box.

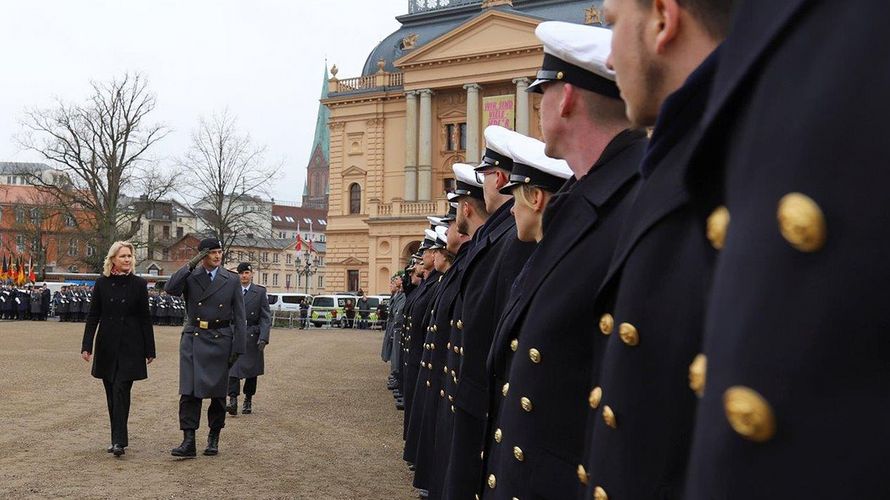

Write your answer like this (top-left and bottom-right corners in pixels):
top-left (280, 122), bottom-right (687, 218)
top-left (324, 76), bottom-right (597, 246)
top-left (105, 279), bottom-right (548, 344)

top-left (583, 0), bottom-right (732, 498)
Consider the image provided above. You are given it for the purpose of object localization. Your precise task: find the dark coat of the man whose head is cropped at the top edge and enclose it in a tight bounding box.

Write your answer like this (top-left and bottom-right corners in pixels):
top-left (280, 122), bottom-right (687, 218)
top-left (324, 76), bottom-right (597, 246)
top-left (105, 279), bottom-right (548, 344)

top-left (582, 51), bottom-right (719, 499)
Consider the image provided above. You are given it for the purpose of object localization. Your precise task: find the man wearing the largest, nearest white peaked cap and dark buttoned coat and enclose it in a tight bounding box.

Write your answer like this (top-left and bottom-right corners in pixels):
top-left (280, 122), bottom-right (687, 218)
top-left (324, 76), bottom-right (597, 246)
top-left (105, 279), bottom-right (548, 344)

top-left (482, 25), bottom-right (646, 499)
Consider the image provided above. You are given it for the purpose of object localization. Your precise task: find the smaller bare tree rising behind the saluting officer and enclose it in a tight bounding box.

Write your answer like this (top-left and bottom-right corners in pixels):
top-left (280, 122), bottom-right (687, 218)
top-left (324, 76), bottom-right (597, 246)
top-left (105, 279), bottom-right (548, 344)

top-left (182, 111), bottom-right (278, 262)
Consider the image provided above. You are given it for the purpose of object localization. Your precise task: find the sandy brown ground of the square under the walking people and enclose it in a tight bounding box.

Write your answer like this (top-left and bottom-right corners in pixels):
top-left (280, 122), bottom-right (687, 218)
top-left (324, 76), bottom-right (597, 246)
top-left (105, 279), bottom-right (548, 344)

top-left (0, 321), bottom-right (416, 499)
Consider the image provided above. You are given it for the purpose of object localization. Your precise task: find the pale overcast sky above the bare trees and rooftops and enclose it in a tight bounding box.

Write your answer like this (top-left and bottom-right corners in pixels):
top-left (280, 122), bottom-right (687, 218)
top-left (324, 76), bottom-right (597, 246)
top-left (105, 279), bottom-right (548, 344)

top-left (0, 0), bottom-right (408, 201)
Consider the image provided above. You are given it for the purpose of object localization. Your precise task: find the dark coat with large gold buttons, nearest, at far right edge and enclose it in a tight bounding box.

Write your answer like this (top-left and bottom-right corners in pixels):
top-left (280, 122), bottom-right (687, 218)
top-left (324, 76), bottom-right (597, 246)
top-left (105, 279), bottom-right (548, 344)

top-left (686, 0), bottom-right (890, 500)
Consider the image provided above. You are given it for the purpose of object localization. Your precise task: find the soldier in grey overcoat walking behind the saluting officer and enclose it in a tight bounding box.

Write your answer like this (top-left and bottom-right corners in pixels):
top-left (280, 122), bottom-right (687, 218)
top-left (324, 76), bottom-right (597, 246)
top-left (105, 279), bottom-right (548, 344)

top-left (226, 262), bottom-right (272, 415)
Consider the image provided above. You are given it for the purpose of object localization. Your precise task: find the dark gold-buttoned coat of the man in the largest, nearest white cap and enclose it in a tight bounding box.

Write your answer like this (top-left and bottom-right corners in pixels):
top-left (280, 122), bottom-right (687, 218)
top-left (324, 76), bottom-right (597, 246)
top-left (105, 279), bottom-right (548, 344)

top-left (483, 131), bottom-right (646, 499)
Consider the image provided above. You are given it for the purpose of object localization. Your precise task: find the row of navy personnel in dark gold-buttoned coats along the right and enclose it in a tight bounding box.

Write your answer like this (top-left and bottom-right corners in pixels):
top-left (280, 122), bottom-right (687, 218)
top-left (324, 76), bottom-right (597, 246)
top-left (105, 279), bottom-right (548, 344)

top-left (383, 0), bottom-right (890, 500)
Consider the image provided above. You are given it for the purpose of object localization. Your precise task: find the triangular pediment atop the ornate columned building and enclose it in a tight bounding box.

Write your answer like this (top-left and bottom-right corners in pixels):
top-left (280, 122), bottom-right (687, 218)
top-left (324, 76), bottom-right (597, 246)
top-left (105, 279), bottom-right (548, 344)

top-left (395, 10), bottom-right (542, 69)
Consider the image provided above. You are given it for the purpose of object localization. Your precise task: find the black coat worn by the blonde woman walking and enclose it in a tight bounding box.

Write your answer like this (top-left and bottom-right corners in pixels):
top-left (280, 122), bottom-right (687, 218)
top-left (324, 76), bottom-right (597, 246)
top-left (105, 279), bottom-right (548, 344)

top-left (80, 274), bottom-right (156, 381)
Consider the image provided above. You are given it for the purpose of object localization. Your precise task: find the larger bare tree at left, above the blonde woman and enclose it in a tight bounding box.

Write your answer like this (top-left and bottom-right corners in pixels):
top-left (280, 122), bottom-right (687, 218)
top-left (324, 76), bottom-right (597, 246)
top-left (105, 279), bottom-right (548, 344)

top-left (19, 74), bottom-right (173, 271)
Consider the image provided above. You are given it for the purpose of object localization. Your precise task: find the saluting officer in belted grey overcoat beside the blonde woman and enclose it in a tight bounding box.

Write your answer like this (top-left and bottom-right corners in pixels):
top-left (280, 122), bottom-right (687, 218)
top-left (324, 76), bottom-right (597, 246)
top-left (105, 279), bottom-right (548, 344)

top-left (164, 238), bottom-right (246, 457)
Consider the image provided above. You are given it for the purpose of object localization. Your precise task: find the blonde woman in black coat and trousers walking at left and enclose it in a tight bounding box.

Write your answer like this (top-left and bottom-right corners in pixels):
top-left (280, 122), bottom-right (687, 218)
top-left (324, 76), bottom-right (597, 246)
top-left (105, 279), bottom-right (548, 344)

top-left (81, 241), bottom-right (155, 457)
